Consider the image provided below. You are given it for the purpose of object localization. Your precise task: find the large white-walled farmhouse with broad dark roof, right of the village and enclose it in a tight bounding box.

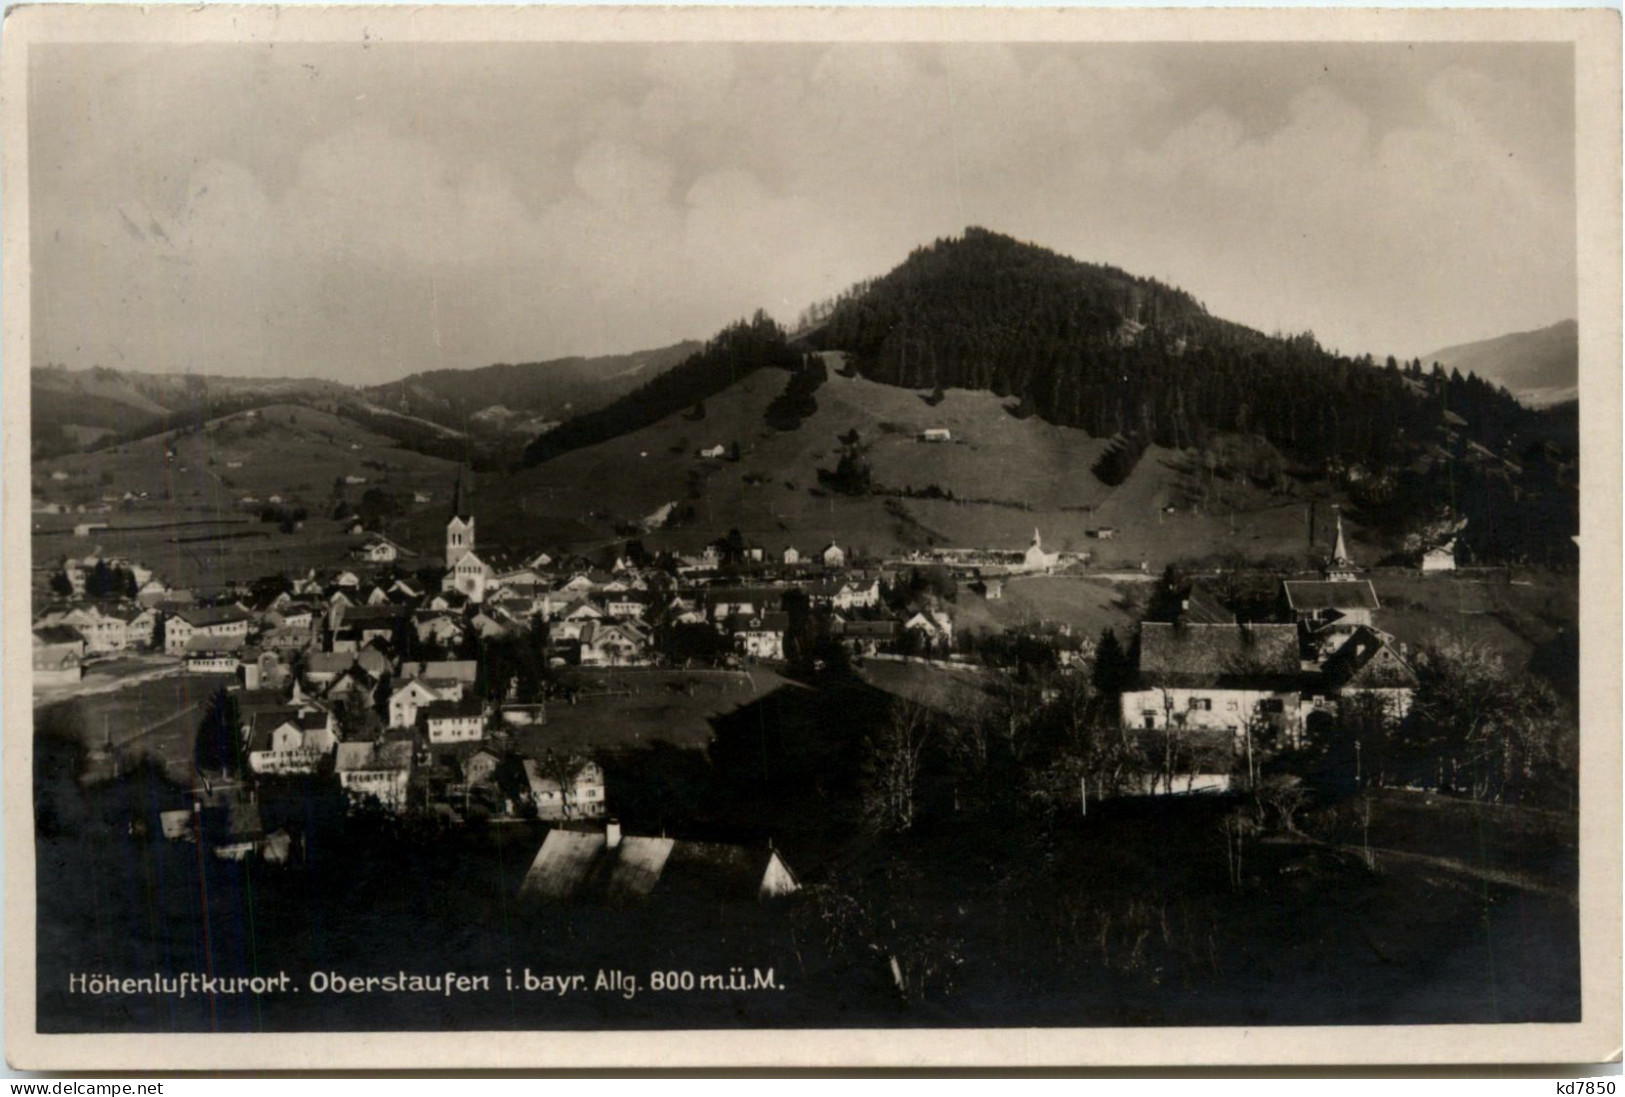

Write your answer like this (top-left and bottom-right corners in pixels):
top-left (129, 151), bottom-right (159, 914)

top-left (1121, 621), bottom-right (1303, 741)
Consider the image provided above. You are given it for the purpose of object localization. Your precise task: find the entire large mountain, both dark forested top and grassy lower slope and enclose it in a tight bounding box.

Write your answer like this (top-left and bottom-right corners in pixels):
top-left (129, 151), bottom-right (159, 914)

top-left (512, 228), bottom-right (1578, 561)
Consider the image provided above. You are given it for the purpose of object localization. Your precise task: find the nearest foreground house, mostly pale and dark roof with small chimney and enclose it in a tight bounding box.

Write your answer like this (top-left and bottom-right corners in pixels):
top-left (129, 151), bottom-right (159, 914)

top-left (520, 822), bottom-right (800, 907)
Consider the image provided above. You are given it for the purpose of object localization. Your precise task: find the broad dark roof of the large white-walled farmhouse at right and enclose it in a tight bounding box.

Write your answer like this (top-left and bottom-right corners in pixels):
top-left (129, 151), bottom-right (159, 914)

top-left (1139, 621), bottom-right (1300, 687)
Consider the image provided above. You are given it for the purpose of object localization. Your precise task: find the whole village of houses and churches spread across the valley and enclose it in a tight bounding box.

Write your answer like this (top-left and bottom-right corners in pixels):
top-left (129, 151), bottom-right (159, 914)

top-left (33, 451), bottom-right (1443, 916)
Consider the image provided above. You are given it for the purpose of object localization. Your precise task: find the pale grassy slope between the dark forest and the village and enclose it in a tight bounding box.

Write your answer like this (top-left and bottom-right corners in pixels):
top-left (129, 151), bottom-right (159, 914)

top-left (478, 369), bottom-right (1359, 569)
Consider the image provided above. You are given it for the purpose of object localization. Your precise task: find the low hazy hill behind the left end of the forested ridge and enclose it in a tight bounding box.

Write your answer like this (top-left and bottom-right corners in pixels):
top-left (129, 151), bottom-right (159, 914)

top-left (362, 341), bottom-right (700, 436)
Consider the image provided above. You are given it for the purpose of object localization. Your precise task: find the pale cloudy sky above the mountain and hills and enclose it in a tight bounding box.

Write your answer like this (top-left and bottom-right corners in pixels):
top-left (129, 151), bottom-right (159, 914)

top-left (29, 42), bottom-right (1576, 384)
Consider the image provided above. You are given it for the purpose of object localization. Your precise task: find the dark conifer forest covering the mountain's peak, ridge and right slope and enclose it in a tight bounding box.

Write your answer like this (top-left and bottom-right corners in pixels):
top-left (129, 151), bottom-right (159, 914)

top-left (525, 228), bottom-right (1578, 562)
